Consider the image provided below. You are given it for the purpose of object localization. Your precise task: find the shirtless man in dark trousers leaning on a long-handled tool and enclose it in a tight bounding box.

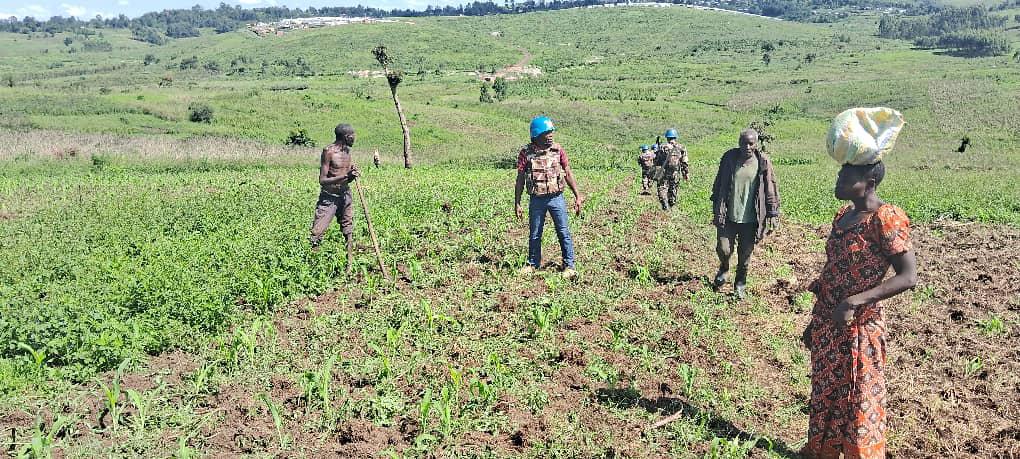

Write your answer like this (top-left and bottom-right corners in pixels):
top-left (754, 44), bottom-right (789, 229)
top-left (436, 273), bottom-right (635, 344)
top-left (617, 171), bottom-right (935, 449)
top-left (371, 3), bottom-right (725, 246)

top-left (309, 124), bottom-right (361, 272)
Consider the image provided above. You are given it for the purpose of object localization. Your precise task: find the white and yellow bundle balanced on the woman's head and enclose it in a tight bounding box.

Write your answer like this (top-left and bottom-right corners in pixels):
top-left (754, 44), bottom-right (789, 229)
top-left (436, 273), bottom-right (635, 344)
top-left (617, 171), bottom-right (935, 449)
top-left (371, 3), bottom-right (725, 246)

top-left (825, 107), bottom-right (904, 165)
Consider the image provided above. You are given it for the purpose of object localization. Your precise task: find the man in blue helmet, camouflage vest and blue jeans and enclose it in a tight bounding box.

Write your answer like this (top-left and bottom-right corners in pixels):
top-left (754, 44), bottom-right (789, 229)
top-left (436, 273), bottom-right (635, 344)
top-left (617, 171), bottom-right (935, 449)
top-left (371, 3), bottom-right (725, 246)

top-left (514, 116), bottom-right (584, 278)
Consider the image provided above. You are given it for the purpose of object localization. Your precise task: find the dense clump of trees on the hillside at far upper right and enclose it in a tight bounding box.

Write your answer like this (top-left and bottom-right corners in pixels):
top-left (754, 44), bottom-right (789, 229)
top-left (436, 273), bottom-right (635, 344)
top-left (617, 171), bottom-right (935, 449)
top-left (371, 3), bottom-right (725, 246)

top-left (878, 5), bottom-right (1010, 56)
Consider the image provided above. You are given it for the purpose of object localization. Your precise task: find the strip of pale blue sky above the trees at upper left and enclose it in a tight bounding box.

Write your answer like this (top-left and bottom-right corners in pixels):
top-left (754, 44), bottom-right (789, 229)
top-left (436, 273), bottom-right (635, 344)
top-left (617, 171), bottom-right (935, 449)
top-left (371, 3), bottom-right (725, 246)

top-left (0, 0), bottom-right (468, 19)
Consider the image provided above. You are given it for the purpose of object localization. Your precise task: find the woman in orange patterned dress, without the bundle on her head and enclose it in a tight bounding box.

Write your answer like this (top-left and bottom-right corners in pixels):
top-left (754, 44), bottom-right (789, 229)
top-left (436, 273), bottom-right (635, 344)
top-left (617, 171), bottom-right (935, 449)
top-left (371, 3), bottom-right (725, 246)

top-left (803, 162), bottom-right (917, 459)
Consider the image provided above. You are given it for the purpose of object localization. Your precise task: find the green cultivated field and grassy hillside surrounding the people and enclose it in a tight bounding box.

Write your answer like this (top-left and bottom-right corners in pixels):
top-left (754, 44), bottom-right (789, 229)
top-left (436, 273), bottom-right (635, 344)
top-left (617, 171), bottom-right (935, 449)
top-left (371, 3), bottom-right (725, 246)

top-left (0, 7), bottom-right (1020, 458)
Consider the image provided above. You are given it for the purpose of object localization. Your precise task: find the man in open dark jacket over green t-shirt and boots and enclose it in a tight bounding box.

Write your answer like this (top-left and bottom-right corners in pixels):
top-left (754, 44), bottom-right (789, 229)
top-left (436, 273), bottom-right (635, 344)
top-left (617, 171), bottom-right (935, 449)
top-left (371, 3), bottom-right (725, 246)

top-left (712, 130), bottom-right (779, 299)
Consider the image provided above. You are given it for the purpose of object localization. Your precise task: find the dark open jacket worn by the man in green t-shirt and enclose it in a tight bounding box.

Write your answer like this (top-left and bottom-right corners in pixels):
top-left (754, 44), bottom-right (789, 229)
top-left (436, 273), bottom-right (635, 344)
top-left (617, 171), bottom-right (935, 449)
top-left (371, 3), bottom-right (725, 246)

top-left (712, 148), bottom-right (779, 241)
